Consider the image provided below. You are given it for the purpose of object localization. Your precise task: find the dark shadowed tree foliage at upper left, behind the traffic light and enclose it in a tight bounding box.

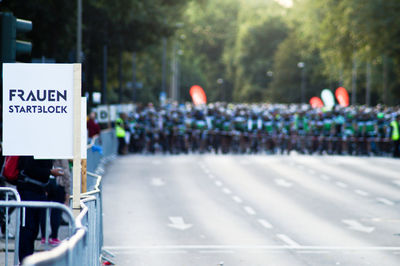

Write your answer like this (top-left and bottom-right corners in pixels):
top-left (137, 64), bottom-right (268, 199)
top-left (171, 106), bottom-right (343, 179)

top-left (1, 0), bottom-right (191, 106)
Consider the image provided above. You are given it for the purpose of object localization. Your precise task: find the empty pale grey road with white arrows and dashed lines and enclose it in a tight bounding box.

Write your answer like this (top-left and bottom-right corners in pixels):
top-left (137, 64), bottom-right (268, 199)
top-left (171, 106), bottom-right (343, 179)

top-left (103, 155), bottom-right (400, 266)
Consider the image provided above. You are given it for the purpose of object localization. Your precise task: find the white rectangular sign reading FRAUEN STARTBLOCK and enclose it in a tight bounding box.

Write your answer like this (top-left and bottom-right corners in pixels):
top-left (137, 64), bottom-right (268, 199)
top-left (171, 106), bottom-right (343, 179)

top-left (3, 64), bottom-right (86, 159)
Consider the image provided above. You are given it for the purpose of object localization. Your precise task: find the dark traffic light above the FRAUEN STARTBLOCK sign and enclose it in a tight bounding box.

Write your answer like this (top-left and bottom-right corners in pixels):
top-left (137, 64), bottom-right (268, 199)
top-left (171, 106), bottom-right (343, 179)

top-left (0, 12), bottom-right (32, 63)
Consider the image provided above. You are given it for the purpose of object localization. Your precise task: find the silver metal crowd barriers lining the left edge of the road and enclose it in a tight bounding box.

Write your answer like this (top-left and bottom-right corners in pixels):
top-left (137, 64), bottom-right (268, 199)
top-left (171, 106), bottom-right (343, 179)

top-left (0, 130), bottom-right (117, 266)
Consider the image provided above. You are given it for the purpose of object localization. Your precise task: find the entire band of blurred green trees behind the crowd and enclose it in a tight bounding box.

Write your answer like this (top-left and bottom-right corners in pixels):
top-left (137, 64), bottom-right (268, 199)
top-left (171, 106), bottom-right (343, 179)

top-left (1, 0), bottom-right (400, 104)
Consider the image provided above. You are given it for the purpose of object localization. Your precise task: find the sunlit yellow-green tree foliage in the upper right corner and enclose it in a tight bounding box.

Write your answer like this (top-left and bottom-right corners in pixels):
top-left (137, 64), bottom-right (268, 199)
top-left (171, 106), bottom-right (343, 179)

top-left (296, 0), bottom-right (400, 104)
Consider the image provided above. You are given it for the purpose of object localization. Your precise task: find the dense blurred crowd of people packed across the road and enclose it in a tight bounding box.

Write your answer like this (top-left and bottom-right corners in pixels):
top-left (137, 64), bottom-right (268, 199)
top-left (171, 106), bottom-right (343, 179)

top-left (112, 103), bottom-right (400, 156)
